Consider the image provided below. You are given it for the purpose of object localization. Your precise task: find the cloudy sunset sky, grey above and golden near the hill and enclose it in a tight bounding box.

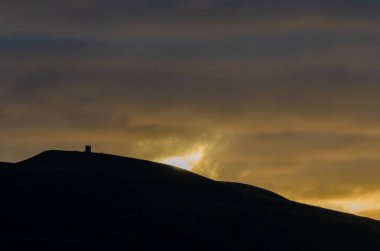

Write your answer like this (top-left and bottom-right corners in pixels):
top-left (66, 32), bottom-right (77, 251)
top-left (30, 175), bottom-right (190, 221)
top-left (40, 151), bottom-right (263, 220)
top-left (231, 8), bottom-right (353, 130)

top-left (0, 0), bottom-right (380, 219)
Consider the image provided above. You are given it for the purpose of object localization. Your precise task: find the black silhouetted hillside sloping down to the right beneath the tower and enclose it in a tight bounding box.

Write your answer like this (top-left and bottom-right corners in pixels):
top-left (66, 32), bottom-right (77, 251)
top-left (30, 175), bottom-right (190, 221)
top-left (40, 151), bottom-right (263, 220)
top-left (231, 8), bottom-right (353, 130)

top-left (0, 151), bottom-right (380, 250)
